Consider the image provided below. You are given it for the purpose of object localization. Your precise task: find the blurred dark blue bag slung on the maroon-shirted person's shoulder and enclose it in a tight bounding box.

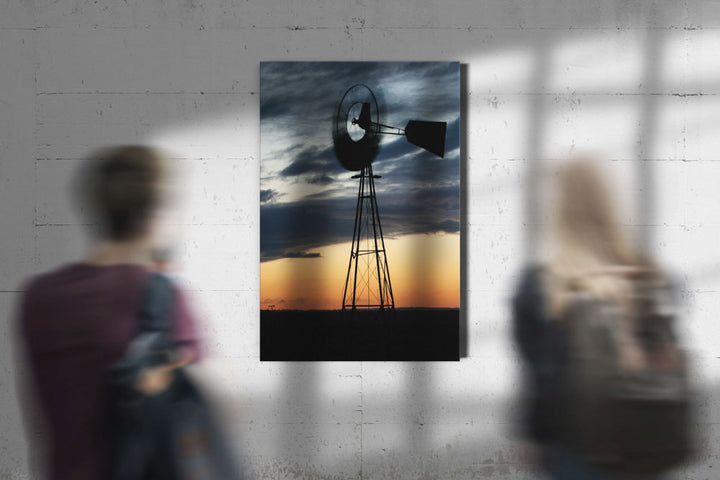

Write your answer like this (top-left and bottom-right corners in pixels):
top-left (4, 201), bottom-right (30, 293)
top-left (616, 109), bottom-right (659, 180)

top-left (106, 274), bottom-right (243, 480)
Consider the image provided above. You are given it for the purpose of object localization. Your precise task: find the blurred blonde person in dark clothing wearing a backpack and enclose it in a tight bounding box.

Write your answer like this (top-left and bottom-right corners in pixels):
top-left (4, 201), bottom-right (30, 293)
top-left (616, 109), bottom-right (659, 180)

top-left (513, 159), bottom-right (687, 480)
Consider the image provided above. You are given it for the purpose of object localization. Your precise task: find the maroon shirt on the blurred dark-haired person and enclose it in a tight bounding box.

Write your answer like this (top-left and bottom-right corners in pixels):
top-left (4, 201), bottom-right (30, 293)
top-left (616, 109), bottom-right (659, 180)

top-left (19, 263), bottom-right (199, 480)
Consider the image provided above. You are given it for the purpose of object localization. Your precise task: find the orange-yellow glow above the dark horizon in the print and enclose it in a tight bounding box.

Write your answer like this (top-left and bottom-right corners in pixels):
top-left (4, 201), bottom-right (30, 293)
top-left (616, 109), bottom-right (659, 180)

top-left (260, 233), bottom-right (460, 310)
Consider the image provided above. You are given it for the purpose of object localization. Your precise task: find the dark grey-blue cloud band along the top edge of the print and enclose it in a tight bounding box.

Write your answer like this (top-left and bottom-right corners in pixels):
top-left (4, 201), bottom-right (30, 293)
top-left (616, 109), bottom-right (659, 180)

top-left (260, 62), bottom-right (459, 144)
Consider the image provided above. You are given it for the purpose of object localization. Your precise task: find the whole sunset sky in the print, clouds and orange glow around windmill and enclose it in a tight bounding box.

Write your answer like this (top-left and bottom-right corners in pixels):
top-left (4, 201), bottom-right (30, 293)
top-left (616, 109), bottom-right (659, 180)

top-left (260, 62), bottom-right (460, 309)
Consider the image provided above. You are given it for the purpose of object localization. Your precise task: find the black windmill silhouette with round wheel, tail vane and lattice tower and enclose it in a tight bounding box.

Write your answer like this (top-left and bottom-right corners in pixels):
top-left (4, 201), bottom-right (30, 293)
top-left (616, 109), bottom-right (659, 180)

top-left (333, 83), bottom-right (447, 311)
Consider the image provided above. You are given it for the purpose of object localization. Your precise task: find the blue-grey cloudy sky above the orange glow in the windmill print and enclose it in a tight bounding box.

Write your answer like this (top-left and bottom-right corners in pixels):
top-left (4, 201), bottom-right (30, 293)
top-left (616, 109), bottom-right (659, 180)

top-left (260, 62), bottom-right (460, 261)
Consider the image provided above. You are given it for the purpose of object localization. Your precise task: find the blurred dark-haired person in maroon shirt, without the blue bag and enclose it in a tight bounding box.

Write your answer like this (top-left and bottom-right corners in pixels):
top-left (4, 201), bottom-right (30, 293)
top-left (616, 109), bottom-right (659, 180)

top-left (17, 146), bottom-right (199, 480)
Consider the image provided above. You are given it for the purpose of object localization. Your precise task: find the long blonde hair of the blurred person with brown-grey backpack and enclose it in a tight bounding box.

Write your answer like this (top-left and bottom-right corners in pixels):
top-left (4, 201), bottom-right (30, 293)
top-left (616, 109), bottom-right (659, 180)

top-left (544, 158), bottom-right (654, 318)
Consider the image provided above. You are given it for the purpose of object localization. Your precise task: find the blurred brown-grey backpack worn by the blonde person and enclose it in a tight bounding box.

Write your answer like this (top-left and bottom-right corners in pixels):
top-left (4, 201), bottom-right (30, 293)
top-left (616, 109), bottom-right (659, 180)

top-left (563, 279), bottom-right (691, 475)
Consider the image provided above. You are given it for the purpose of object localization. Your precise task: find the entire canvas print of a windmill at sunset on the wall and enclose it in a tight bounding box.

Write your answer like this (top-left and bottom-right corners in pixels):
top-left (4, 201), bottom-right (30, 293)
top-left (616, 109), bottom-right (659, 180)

top-left (260, 62), bottom-right (460, 360)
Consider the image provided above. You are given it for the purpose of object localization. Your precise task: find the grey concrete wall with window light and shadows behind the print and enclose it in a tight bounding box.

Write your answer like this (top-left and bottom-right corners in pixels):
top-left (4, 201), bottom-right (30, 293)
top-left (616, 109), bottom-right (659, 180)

top-left (0, 0), bottom-right (720, 480)
